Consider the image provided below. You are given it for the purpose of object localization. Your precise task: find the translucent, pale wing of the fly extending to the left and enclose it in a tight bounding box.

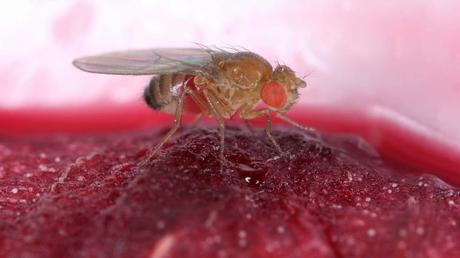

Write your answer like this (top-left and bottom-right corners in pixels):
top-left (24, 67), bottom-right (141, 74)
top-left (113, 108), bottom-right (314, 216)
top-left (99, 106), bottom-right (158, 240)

top-left (73, 48), bottom-right (213, 75)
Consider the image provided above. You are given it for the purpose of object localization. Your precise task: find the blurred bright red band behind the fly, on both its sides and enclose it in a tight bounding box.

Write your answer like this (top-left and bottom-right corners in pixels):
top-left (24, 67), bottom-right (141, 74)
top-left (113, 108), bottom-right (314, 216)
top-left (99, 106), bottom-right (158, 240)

top-left (0, 103), bottom-right (460, 185)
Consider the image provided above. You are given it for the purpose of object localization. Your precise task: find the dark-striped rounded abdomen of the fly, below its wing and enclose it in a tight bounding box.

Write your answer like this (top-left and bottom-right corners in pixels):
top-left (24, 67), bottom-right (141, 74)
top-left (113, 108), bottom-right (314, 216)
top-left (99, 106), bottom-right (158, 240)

top-left (144, 73), bottom-right (187, 112)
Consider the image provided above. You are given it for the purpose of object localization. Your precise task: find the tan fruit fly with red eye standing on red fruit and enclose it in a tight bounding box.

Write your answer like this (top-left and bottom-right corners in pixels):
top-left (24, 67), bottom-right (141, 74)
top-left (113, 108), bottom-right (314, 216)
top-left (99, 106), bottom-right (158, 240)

top-left (73, 47), bottom-right (310, 164)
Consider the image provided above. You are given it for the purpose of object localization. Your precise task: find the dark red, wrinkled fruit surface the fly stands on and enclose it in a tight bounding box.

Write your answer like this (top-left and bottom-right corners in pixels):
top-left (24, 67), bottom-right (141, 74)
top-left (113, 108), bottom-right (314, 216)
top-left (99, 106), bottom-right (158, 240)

top-left (0, 127), bottom-right (460, 258)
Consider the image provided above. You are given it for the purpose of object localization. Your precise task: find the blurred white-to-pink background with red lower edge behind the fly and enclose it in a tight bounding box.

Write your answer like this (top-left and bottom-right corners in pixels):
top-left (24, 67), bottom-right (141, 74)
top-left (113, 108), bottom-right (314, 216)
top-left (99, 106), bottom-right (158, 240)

top-left (0, 0), bottom-right (460, 180)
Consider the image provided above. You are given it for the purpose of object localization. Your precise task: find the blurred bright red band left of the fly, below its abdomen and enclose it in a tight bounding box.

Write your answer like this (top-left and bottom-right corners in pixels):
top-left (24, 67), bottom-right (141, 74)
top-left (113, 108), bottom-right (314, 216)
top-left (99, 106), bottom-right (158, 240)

top-left (0, 103), bottom-right (167, 135)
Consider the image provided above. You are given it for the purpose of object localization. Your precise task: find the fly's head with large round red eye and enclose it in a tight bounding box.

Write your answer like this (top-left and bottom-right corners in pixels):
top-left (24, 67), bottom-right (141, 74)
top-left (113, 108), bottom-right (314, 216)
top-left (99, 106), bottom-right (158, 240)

top-left (261, 65), bottom-right (306, 113)
